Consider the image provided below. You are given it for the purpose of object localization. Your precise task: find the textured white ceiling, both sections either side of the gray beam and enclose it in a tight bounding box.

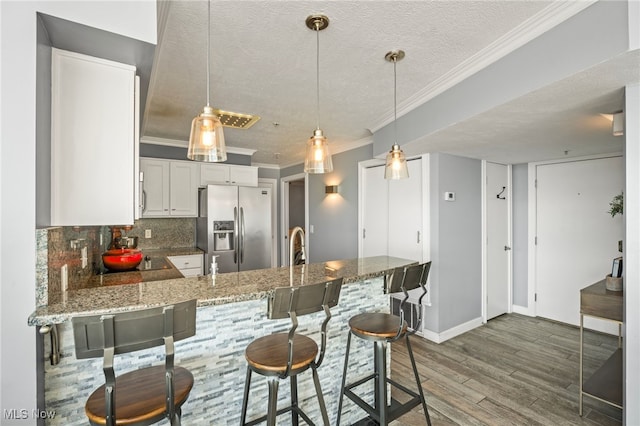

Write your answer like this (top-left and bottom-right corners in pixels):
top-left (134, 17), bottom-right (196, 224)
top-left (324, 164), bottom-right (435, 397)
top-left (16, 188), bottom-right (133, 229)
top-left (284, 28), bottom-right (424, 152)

top-left (142, 0), bottom-right (640, 167)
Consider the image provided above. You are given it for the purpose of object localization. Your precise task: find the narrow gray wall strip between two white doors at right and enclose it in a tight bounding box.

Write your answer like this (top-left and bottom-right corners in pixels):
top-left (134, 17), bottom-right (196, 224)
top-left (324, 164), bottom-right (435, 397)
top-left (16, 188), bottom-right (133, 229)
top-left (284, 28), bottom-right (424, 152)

top-left (511, 164), bottom-right (529, 307)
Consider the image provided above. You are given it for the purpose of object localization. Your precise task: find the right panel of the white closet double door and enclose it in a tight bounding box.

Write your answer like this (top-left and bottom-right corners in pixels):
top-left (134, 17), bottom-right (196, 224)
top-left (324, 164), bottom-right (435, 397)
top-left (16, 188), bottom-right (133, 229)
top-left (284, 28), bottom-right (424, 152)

top-left (388, 159), bottom-right (423, 262)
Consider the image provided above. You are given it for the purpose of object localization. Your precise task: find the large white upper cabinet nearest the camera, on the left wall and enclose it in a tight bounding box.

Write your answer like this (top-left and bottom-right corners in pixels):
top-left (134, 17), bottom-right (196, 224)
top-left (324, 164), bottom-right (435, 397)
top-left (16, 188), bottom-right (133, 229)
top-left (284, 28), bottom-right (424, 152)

top-left (51, 49), bottom-right (138, 226)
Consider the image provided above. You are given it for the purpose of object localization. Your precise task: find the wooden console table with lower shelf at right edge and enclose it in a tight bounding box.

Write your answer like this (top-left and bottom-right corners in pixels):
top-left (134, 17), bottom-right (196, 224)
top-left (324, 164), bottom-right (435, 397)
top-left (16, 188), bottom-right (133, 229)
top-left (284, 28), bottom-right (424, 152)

top-left (580, 280), bottom-right (624, 416)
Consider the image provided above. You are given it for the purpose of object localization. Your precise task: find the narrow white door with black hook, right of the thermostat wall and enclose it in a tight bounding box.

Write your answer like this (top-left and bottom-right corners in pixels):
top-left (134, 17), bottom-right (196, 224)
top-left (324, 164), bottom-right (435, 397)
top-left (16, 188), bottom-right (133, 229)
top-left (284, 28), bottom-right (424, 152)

top-left (486, 162), bottom-right (511, 320)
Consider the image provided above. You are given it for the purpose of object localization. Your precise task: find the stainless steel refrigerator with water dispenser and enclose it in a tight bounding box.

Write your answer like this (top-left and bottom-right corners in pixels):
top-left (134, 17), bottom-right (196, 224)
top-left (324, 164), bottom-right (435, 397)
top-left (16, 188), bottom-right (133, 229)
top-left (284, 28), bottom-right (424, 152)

top-left (196, 185), bottom-right (273, 273)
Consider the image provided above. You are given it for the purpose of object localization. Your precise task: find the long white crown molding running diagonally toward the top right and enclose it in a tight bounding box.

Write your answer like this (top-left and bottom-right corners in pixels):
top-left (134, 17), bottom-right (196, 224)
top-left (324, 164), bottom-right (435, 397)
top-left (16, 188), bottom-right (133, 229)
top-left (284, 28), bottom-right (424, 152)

top-left (371, 0), bottom-right (598, 132)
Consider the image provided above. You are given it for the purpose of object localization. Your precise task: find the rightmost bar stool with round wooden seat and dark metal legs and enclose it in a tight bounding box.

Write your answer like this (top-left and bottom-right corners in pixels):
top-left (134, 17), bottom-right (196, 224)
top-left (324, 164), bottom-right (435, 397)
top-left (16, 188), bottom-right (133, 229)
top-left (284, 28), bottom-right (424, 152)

top-left (336, 262), bottom-right (431, 426)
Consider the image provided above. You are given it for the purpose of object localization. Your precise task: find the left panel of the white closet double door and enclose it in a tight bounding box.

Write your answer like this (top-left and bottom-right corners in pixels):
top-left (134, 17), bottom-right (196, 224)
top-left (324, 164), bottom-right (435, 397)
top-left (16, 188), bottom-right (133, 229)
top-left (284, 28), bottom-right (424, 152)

top-left (360, 165), bottom-right (389, 257)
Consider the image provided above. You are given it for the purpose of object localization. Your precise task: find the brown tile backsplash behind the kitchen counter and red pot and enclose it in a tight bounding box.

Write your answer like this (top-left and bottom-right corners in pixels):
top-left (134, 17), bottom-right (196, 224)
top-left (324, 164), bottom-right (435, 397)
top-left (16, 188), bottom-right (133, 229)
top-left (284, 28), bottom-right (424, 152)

top-left (36, 218), bottom-right (196, 306)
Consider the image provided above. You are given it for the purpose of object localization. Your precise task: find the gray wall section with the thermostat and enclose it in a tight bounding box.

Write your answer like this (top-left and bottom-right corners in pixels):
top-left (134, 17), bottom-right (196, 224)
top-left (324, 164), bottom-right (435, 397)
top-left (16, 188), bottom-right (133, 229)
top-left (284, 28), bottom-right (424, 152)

top-left (425, 154), bottom-right (482, 333)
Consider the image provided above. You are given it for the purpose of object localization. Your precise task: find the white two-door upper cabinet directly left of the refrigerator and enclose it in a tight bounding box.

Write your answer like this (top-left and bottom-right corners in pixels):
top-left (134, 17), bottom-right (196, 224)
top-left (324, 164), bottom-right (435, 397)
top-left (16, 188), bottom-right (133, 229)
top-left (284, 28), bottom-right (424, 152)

top-left (140, 158), bottom-right (198, 217)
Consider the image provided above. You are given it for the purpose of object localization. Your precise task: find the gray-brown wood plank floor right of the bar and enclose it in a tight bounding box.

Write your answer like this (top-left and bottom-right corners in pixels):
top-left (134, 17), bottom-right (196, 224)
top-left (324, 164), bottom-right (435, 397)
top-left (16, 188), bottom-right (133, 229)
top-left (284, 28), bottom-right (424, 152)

top-left (391, 314), bottom-right (622, 426)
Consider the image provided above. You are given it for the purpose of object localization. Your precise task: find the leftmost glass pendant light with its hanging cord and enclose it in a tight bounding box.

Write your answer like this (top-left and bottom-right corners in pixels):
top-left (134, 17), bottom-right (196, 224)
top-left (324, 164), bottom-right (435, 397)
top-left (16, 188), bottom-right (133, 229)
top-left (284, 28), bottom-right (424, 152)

top-left (187, 1), bottom-right (227, 163)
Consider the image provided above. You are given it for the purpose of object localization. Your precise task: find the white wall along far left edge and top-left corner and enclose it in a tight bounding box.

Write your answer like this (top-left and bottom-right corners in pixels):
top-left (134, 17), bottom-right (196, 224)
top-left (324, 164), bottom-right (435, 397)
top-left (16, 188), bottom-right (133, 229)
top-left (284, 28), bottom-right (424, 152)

top-left (0, 0), bottom-right (157, 426)
